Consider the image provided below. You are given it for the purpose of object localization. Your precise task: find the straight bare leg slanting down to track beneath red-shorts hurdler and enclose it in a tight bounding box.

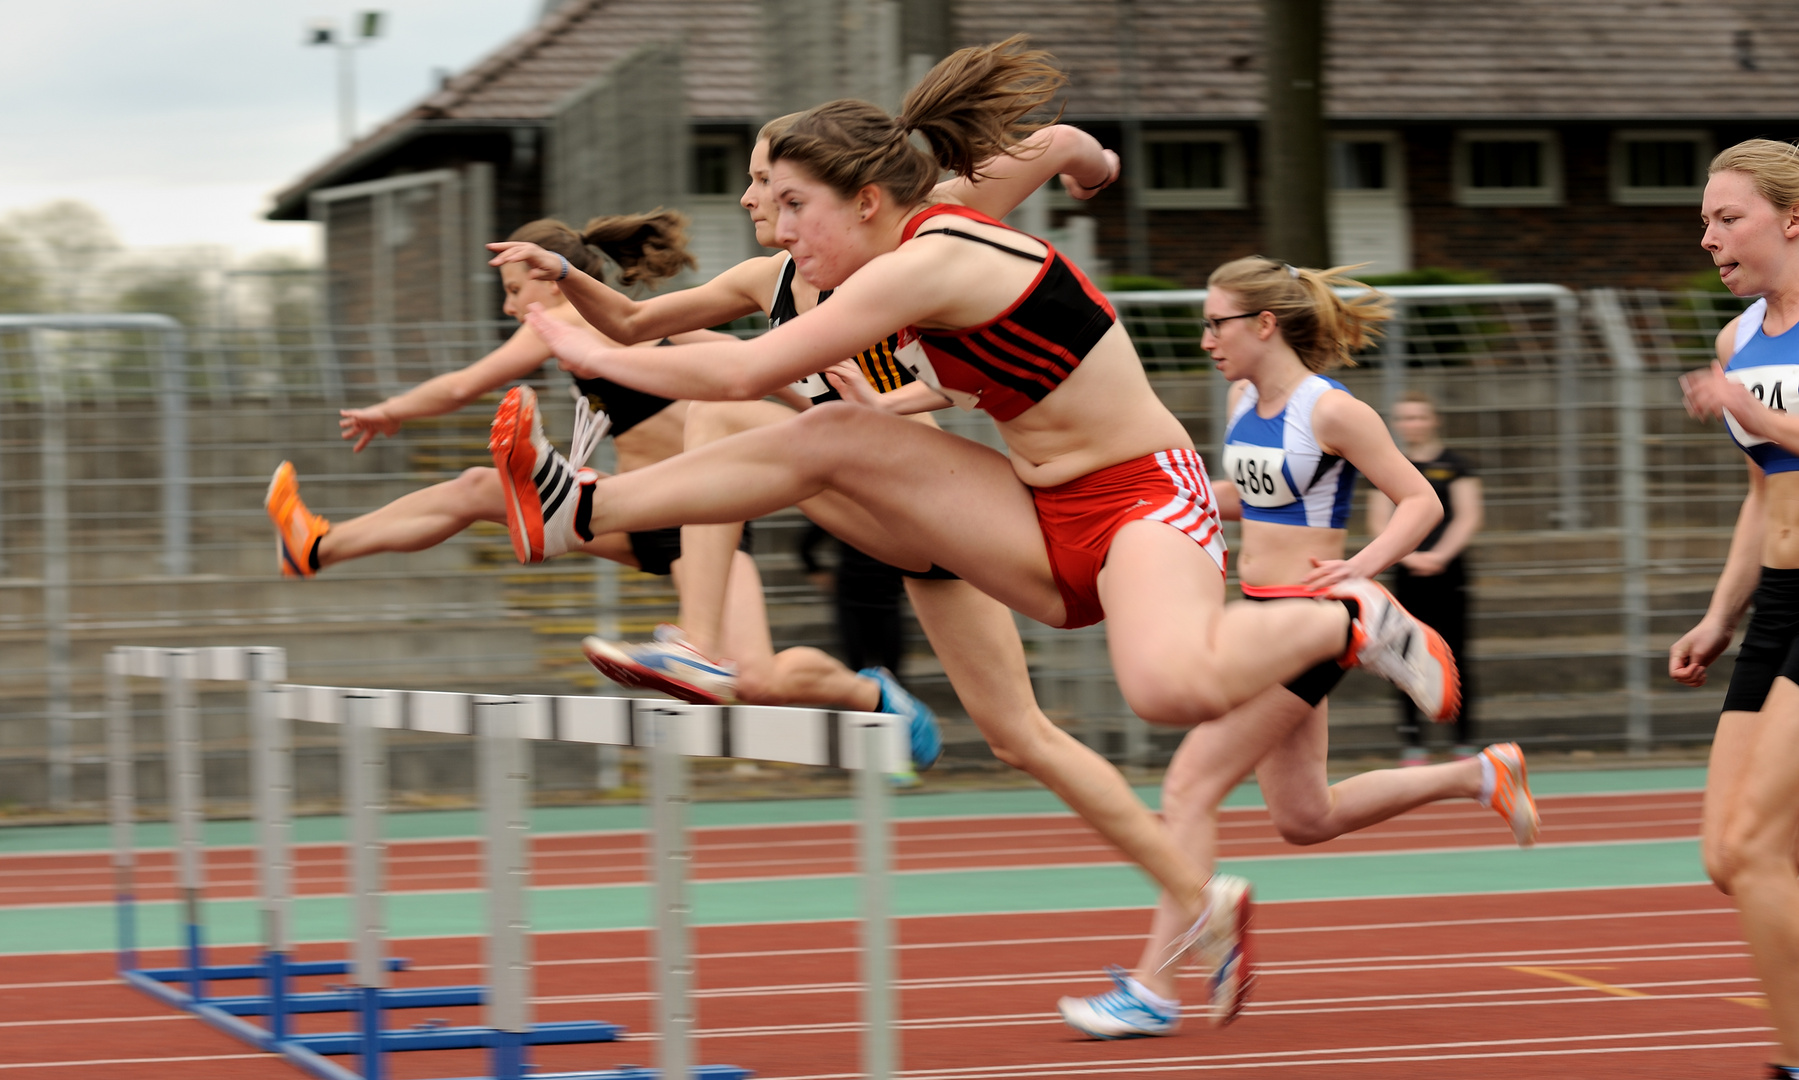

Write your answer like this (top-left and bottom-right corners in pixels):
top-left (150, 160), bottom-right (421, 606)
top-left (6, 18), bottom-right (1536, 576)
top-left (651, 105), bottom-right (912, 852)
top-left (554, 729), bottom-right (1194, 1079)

top-left (905, 579), bottom-right (1207, 932)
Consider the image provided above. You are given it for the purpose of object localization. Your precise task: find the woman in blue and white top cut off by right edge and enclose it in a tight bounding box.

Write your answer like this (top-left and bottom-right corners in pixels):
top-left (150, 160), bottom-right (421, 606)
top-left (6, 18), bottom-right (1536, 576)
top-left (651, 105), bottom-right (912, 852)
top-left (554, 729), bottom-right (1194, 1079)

top-left (1668, 139), bottom-right (1799, 1078)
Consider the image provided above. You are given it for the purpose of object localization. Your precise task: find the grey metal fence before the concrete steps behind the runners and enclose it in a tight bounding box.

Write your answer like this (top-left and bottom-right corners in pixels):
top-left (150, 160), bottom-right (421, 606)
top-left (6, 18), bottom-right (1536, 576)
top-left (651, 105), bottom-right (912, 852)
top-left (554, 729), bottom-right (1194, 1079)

top-left (0, 286), bottom-right (1743, 805)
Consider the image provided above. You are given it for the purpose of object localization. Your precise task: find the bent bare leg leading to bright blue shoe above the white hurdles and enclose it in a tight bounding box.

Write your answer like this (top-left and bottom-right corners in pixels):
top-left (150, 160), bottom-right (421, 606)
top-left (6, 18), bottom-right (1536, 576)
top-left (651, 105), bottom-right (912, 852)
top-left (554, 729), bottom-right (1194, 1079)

top-left (708, 536), bottom-right (882, 713)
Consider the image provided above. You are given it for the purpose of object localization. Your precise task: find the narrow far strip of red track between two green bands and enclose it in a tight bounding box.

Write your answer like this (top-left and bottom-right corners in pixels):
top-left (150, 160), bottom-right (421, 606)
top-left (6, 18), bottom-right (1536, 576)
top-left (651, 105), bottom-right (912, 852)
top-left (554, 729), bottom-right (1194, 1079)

top-left (0, 792), bottom-right (1700, 907)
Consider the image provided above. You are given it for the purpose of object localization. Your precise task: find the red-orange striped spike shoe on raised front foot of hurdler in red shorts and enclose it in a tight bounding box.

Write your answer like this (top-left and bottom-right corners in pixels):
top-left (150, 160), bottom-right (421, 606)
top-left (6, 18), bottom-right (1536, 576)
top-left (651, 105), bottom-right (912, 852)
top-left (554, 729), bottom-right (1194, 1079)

top-left (488, 387), bottom-right (599, 563)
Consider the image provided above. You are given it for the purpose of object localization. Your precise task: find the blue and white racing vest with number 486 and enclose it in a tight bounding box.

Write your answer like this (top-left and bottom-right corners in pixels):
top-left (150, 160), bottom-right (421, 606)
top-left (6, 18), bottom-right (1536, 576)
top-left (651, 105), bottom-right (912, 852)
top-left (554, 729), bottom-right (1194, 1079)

top-left (1225, 374), bottom-right (1356, 529)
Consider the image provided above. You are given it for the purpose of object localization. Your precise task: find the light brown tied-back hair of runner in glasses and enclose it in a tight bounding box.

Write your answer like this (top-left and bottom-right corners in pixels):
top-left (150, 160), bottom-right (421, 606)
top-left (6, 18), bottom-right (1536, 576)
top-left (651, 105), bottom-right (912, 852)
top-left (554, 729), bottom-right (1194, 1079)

top-left (1205, 256), bottom-right (1392, 371)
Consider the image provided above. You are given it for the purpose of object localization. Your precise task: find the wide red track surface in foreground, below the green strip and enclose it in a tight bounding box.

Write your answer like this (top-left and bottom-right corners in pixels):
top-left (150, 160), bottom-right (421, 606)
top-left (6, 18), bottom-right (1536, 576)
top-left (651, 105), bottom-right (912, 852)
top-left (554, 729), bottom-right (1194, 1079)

top-left (0, 886), bottom-right (1768, 1080)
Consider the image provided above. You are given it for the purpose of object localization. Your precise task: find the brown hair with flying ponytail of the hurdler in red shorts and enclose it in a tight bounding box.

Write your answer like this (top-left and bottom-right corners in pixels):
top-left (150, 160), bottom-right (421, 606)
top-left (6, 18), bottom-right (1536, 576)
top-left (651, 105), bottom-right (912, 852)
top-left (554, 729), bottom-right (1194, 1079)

top-left (768, 34), bottom-right (1069, 205)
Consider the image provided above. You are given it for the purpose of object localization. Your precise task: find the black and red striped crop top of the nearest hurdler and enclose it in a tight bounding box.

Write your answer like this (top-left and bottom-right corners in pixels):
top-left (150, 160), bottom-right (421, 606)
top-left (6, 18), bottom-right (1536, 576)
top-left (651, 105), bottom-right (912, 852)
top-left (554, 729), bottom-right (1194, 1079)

top-left (901, 203), bottom-right (1117, 419)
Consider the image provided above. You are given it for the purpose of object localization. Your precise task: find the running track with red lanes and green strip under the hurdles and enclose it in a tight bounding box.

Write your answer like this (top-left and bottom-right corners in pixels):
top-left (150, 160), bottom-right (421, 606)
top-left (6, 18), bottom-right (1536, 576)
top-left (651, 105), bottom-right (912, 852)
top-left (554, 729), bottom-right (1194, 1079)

top-left (0, 763), bottom-right (1768, 1080)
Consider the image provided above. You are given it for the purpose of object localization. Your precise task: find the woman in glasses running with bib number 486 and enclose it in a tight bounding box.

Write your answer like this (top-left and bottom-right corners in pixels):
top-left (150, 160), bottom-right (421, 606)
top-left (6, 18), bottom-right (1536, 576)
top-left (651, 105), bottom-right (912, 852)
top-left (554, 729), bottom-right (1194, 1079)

top-left (1061, 257), bottom-right (1536, 1039)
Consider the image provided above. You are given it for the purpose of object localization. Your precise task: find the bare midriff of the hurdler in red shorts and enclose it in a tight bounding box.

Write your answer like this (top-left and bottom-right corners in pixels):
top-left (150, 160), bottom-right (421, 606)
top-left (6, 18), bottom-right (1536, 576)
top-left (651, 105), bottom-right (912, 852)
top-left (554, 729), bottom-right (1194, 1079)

top-left (998, 324), bottom-right (1193, 488)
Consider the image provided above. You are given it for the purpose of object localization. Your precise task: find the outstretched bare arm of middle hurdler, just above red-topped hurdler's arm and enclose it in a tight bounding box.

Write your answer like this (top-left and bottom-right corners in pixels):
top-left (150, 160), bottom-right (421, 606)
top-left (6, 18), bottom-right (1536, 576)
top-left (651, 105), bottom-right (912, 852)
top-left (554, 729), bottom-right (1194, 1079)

top-left (488, 241), bottom-right (772, 346)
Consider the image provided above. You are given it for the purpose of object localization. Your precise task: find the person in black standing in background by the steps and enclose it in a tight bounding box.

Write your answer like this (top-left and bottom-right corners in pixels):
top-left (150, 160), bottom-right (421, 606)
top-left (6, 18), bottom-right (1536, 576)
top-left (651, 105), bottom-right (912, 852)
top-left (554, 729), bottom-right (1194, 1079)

top-left (1367, 391), bottom-right (1484, 765)
